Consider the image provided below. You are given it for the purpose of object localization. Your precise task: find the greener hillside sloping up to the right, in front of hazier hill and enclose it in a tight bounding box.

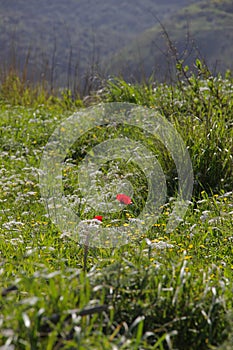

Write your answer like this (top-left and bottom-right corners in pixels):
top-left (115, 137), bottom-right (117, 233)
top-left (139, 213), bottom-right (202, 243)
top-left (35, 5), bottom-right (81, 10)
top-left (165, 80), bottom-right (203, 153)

top-left (109, 1), bottom-right (233, 80)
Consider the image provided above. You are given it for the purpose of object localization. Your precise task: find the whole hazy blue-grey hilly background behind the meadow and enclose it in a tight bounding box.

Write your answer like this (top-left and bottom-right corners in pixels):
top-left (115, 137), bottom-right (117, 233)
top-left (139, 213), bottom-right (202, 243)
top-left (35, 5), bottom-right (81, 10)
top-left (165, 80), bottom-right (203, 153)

top-left (0, 0), bottom-right (233, 90)
